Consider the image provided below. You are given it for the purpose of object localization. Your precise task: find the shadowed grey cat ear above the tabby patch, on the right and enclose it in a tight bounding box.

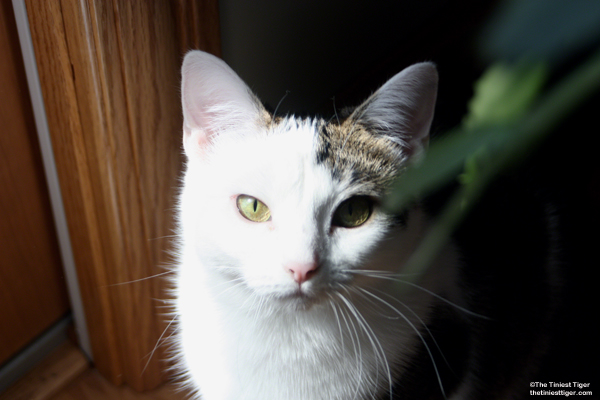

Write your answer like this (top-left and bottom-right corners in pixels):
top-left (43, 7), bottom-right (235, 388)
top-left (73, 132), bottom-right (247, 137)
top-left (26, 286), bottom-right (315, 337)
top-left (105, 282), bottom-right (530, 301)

top-left (352, 62), bottom-right (438, 158)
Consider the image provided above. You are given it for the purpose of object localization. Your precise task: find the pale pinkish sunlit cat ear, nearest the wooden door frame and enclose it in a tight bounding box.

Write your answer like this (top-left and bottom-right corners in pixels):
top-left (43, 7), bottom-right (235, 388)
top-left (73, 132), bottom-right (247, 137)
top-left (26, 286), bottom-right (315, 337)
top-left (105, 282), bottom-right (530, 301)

top-left (181, 50), bottom-right (262, 158)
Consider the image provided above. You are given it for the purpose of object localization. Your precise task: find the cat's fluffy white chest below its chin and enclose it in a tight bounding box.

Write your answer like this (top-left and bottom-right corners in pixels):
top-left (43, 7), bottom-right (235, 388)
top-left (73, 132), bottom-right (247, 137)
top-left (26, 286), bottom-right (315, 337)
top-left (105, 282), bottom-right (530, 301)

top-left (176, 278), bottom-right (406, 400)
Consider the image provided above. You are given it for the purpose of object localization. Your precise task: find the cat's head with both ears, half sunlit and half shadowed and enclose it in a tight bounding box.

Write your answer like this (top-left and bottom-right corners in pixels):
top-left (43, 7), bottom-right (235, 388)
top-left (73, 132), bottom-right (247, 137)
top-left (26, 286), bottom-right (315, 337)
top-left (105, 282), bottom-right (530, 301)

top-left (180, 51), bottom-right (437, 310)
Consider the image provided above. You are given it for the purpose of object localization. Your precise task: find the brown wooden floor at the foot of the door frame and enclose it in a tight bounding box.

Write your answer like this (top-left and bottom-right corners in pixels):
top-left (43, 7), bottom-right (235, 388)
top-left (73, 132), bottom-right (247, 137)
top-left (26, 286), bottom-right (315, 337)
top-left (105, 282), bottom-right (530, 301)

top-left (0, 342), bottom-right (189, 400)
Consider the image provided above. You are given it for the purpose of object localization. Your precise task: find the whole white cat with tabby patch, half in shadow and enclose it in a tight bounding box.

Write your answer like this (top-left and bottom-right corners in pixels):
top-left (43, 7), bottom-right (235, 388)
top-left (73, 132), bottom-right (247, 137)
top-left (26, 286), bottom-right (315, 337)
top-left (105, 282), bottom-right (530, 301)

top-left (174, 51), bottom-right (568, 400)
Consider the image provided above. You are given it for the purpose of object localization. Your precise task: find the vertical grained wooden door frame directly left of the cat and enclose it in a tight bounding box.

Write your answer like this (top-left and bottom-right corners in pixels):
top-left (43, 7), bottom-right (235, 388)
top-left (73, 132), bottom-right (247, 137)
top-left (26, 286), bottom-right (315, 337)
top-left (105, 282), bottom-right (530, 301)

top-left (17, 0), bottom-right (220, 390)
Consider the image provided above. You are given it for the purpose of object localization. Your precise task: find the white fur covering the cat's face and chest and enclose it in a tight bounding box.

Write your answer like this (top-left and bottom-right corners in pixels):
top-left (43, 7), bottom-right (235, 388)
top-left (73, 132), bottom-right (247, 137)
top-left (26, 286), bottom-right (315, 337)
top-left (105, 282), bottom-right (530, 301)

top-left (171, 52), bottom-right (453, 400)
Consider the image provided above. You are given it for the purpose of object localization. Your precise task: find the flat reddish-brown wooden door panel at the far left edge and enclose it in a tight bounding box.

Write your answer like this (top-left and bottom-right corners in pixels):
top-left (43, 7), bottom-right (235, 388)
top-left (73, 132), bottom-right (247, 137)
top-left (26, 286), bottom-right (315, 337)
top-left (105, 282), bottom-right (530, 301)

top-left (0, 1), bottom-right (69, 365)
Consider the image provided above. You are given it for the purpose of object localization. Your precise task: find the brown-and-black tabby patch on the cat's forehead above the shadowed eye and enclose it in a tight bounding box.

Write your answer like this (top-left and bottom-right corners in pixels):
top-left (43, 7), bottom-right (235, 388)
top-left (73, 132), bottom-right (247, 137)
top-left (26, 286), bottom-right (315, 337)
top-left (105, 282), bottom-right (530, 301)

top-left (316, 118), bottom-right (401, 195)
